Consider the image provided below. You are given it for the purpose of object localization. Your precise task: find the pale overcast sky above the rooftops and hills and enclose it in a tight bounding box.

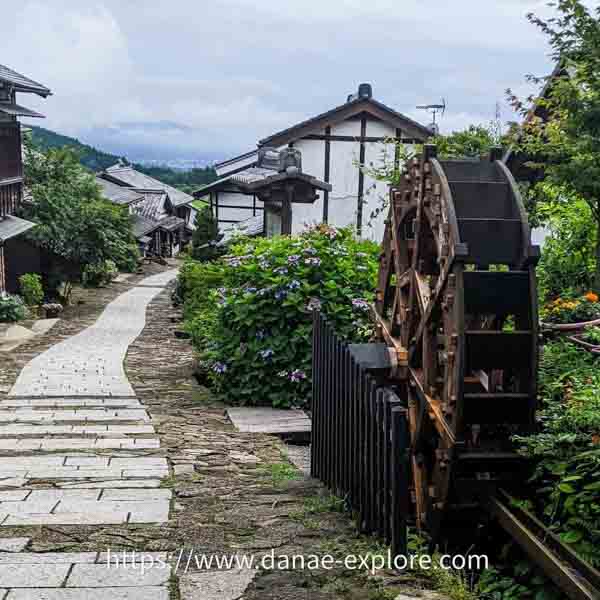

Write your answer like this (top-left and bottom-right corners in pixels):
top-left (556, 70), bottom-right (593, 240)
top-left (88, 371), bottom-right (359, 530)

top-left (0, 0), bottom-right (584, 158)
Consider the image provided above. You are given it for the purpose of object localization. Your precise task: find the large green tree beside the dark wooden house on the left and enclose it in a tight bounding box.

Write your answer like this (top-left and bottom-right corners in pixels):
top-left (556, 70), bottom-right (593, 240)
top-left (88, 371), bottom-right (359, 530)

top-left (23, 142), bottom-right (138, 278)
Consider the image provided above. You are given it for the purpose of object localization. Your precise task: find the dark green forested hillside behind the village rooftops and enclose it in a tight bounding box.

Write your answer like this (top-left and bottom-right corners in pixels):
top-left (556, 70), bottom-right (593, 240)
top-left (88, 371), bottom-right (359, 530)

top-left (31, 125), bottom-right (217, 193)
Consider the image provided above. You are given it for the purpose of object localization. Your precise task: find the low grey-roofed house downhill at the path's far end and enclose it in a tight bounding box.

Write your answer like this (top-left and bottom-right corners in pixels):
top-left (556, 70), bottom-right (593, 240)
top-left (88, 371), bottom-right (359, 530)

top-left (98, 163), bottom-right (196, 257)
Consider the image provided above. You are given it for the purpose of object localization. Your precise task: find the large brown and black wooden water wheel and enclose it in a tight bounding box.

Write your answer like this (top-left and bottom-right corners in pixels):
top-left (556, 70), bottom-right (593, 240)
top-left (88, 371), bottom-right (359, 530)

top-left (375, 146), bottom-right (539, 540)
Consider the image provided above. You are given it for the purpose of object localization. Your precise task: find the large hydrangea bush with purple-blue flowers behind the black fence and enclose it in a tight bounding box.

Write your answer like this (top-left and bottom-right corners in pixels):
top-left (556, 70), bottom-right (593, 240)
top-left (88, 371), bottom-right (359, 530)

top-left (178, 226), bottom-right (379, 407)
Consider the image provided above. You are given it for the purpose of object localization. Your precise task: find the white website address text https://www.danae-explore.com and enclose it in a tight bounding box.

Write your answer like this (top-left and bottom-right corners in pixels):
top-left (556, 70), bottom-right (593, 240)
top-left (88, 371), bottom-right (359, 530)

top-left (106, 549), bottom-right (489, 574)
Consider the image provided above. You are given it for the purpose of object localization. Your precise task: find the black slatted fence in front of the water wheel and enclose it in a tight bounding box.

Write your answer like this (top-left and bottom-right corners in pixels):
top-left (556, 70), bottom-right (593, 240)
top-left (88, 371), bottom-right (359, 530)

top-left (311, 313), bottom-right (409, 555)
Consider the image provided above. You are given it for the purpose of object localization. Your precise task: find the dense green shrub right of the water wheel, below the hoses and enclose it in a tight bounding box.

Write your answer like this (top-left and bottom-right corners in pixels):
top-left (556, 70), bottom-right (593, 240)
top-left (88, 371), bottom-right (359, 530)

top-left (517, 340), bottom-right (600, 566)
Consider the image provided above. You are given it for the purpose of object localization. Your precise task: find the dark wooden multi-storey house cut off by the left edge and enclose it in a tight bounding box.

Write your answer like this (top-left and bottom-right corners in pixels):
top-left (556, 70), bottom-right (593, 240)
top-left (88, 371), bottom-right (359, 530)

top-left (0, 65), bottom-right (51, 292)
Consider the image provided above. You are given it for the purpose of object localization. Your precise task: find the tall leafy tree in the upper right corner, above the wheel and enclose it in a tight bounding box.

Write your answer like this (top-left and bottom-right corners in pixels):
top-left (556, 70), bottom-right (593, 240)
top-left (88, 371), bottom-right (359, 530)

top-left (509, 0), bottom-right (600, 291)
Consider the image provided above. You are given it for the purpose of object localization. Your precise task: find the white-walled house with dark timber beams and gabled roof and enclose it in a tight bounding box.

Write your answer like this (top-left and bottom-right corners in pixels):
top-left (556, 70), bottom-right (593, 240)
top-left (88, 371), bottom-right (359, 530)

top-left (199, 83), bottom-right (432, 240)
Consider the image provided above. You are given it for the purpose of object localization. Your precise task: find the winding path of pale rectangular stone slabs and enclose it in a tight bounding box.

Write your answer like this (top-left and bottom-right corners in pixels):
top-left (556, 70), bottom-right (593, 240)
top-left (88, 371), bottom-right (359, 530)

top-left (0, 270), bottom-right (176, 600)
